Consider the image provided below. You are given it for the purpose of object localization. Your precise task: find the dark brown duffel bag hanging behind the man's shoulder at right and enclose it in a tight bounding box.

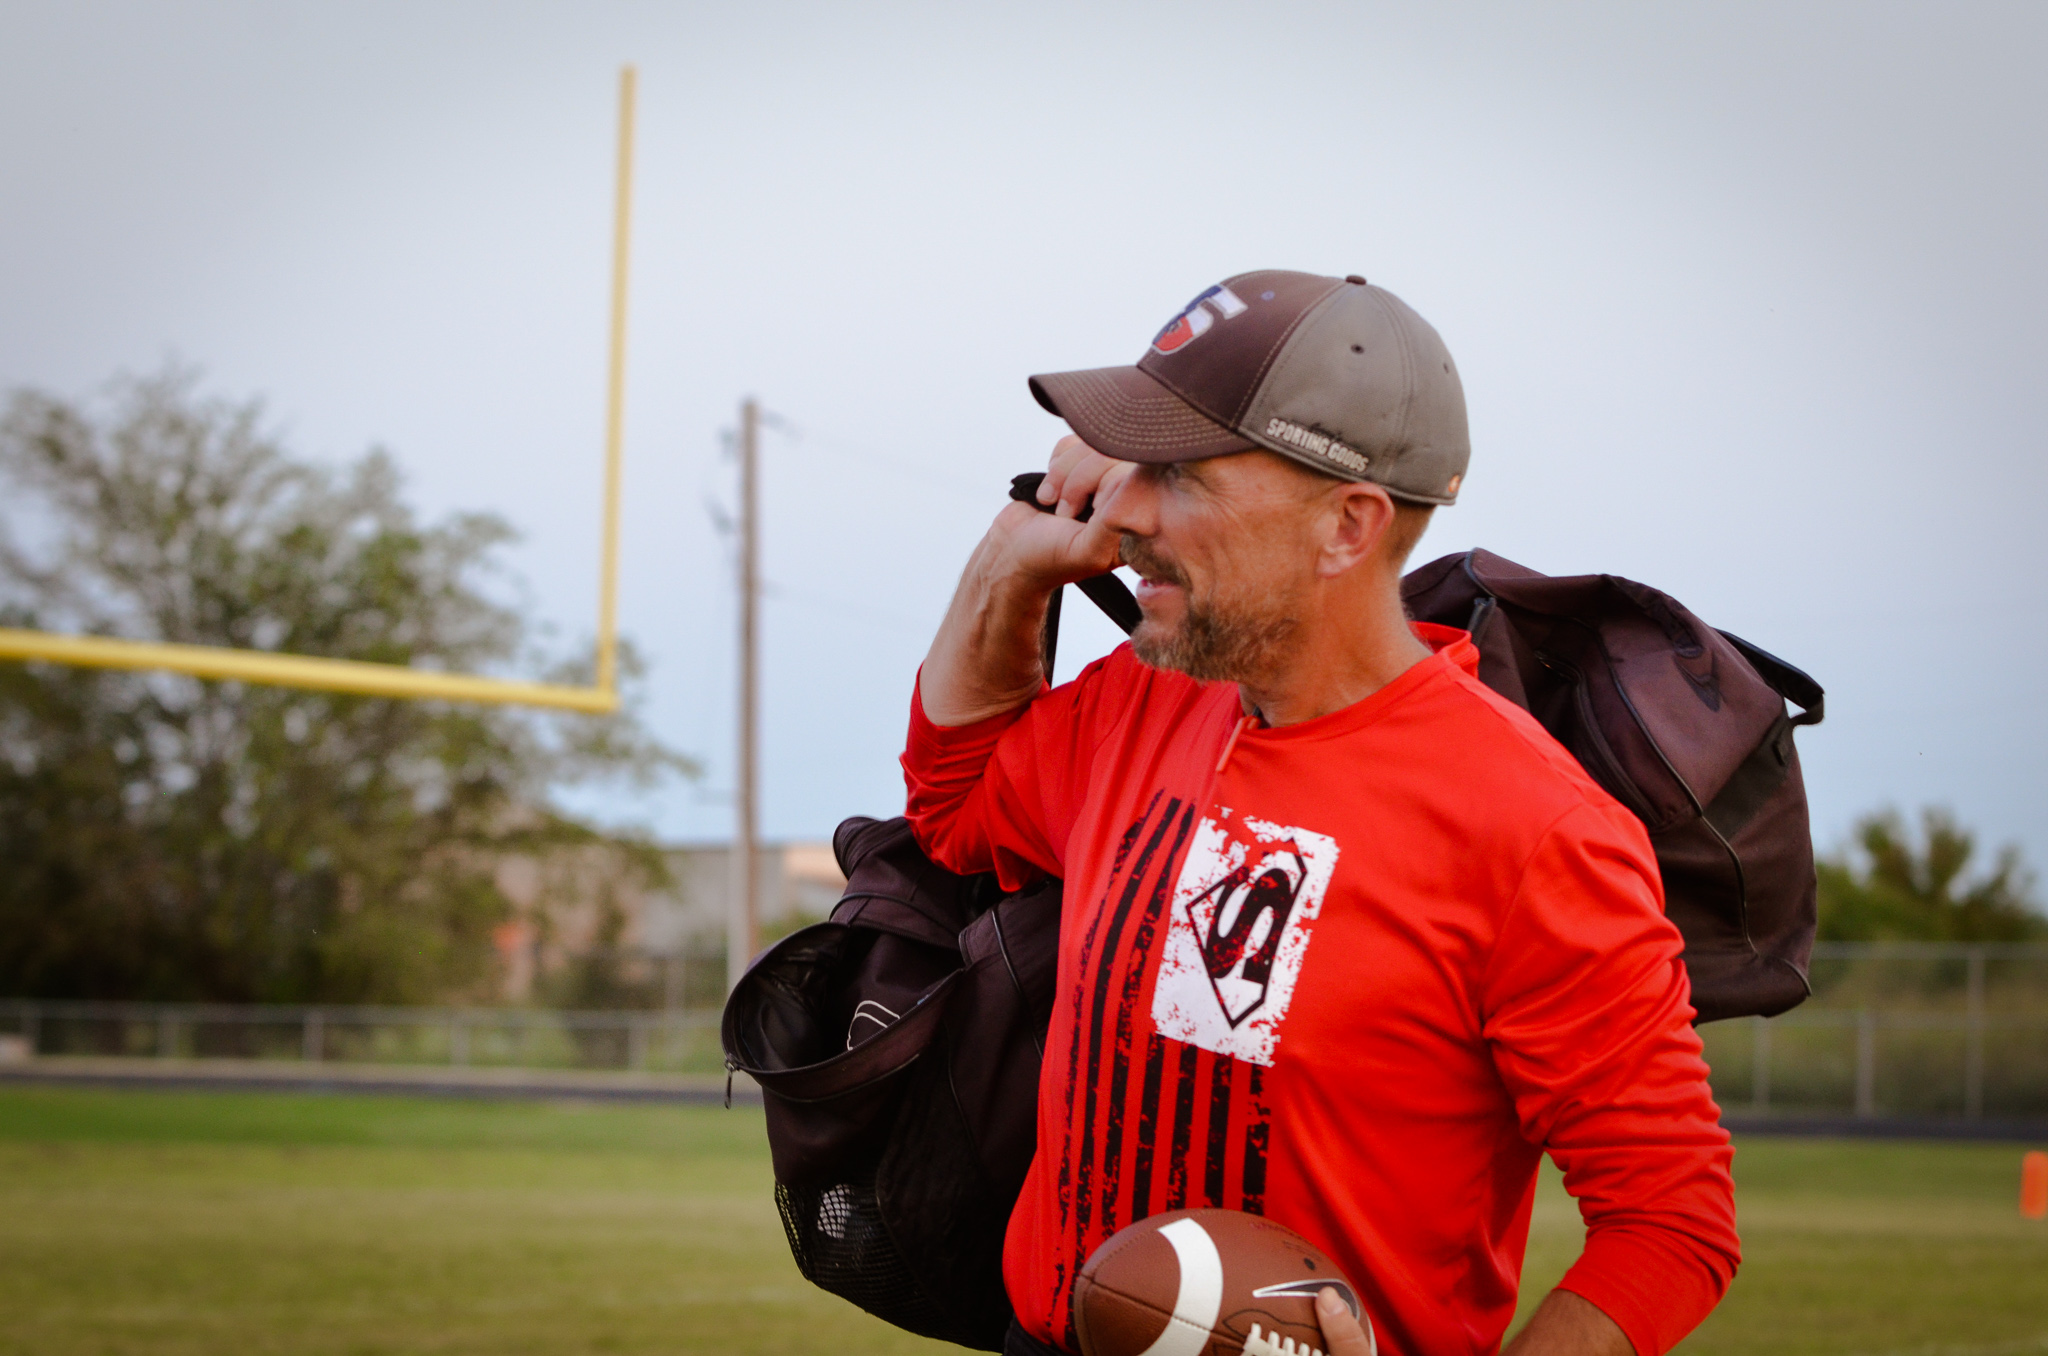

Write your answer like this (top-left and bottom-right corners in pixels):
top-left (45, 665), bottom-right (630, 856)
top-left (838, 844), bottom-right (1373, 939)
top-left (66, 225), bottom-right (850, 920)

top-left (1401, 551), bottom-right (1825, 1022)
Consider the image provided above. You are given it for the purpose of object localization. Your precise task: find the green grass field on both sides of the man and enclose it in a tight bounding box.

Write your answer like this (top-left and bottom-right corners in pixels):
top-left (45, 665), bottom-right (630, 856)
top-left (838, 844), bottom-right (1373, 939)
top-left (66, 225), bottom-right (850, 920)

top-left (0, 1088), bottom-right (2048, 1356)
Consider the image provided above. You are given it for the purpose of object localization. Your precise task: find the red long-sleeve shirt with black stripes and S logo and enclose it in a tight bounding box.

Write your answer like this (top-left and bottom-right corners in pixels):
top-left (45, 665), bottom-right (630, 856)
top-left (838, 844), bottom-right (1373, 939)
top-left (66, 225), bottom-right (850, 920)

top-left (903, 627), bottom-right (1739, 1356)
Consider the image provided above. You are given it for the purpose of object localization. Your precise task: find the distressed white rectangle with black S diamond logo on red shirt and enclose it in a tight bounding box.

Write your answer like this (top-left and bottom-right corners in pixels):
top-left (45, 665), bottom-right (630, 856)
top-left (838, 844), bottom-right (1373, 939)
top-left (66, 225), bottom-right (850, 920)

top-left (1153, 809), bottom-right (1337, 1065)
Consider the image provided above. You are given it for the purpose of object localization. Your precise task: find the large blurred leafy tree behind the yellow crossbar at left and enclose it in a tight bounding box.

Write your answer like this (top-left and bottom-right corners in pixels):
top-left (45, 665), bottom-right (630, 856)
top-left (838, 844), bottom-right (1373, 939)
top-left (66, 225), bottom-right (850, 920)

top-left (0, 371), bottom-right (692, 1002)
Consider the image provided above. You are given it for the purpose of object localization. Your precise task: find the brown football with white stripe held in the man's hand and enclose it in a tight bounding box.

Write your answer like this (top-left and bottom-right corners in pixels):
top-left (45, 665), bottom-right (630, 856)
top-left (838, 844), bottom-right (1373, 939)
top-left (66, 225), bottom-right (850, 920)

top-left (1073, 1211), bottom-right (1376, 1356)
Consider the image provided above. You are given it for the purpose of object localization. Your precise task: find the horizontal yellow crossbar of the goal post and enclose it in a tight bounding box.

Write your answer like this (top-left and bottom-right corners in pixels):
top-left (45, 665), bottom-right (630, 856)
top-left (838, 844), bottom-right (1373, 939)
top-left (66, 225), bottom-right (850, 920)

top-left (0, 627), bottom-right (618, 715)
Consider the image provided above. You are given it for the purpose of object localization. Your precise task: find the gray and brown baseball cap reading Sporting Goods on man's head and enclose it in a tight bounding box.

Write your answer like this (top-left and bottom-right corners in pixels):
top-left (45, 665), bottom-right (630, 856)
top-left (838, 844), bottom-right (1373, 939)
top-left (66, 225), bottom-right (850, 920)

top-left (1030, 270), bottom-right (1473, 504)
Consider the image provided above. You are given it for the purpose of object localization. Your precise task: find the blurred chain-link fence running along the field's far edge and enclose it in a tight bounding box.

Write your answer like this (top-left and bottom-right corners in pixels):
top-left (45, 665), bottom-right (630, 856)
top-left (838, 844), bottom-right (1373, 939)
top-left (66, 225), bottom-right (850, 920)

top-left (0, 942), bottom-right (2048, 1120)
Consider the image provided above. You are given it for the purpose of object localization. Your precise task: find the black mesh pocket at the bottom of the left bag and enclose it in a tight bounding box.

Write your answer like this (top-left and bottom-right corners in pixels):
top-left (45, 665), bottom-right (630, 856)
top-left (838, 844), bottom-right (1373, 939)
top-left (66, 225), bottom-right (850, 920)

top-left (774, 1174), bottom-right (958, 1342)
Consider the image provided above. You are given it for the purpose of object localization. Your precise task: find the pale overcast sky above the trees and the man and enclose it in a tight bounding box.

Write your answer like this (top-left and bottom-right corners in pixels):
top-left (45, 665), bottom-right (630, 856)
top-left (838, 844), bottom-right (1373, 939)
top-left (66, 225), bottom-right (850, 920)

top-left (0, 0), bottom-right (2048, 880)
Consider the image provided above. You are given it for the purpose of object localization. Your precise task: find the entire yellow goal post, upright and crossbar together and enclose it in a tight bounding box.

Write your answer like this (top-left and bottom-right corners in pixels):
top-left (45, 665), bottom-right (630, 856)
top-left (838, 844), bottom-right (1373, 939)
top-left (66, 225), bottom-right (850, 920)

top-left (0, 66), bottom-right (635, 715)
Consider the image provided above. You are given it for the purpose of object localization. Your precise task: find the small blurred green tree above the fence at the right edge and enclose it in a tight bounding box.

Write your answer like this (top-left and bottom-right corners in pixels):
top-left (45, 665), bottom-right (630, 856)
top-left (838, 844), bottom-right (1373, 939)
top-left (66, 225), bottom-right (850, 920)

top-left (1819, 809), bottom-right (2048, 942)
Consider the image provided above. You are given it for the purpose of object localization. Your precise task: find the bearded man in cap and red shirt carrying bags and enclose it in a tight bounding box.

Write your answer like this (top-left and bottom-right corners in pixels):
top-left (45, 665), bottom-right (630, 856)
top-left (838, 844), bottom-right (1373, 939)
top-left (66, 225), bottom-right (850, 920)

top-left (903, 272), bottom-right (1739, 1356)
